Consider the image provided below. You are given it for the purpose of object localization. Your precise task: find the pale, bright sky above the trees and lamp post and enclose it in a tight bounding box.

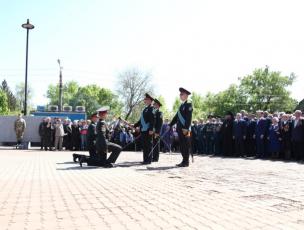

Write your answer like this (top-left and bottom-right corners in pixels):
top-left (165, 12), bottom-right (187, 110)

top-left (0, 0), bottom-right (304, 109)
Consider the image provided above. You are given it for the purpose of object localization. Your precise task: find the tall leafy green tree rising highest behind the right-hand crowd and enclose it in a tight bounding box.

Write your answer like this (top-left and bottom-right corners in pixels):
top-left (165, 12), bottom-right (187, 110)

top-left (239, 66), bottom-right (296, 111)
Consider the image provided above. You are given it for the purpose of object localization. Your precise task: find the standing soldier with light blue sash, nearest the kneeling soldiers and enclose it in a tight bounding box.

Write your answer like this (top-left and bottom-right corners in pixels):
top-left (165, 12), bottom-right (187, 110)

top-left (134, 93), bottom-right (154, 164)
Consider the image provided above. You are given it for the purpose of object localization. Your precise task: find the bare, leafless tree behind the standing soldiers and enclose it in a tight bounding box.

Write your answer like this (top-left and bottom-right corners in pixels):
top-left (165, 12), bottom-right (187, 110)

top-left (117, 68), bottom-right (153, 120)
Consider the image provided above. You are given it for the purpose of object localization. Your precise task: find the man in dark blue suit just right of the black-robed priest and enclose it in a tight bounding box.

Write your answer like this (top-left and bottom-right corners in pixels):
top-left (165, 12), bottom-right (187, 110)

top-left (232, 113), bottom-right (247, 157)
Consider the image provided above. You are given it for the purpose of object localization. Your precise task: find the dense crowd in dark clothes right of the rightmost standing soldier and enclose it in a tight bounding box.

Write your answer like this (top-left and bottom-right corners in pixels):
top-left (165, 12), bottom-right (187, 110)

top-left (191, 110), bottom-right (304, 161)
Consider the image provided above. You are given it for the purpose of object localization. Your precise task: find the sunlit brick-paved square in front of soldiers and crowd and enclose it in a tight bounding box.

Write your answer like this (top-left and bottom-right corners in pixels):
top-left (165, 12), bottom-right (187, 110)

top-left (0, 148), bottom-right (304, 230)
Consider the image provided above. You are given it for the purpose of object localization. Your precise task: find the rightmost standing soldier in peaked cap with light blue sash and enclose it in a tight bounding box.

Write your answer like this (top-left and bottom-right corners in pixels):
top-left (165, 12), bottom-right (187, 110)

top-left (169, 88), bottom-right (193, 167)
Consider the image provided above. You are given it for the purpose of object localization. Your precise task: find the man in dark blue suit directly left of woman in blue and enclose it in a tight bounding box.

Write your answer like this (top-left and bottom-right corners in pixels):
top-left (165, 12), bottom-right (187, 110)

top-left (253, 110), bottom-right (268, 158)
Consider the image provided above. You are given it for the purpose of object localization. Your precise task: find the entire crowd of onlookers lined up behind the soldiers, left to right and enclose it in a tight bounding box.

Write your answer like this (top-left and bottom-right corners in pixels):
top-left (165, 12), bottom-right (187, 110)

top-left (39, 108), bottom-right (304, 161)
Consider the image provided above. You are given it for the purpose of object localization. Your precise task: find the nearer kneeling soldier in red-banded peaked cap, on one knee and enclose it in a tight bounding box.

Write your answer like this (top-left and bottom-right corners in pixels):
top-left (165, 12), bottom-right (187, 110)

top-left (80, 106), bottom-right (122, 168)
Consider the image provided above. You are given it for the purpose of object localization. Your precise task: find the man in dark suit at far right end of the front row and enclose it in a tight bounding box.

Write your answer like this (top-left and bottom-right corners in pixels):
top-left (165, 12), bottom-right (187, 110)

top-left (291, 110), bottom-right (304, 161)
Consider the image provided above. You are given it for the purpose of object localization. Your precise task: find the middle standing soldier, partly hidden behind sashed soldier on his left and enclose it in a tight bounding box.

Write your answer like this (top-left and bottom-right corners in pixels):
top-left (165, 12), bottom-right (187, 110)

top-left (152, 99), bottom-right (163, 162)
